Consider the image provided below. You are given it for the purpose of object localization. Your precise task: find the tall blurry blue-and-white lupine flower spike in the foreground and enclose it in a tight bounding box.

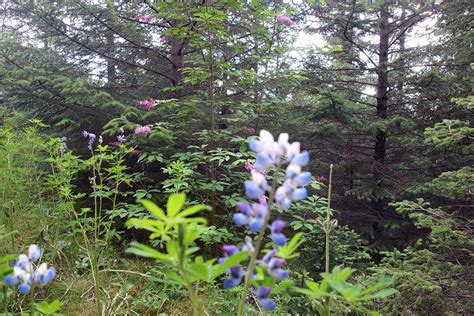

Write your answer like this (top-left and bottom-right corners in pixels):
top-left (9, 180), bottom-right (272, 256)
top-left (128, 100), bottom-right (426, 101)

top-left (218, 130), bottom-right (311, 313)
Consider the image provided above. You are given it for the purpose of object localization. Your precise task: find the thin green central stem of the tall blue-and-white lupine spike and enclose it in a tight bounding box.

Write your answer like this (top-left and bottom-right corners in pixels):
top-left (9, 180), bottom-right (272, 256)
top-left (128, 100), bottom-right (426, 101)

top-left (237, 166), bottom-right (280, 316)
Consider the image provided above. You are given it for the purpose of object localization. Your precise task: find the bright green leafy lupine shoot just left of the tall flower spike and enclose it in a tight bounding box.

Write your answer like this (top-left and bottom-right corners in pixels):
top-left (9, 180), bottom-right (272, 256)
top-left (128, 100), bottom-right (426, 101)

top-left (127, 194), bottom-right (248, 315)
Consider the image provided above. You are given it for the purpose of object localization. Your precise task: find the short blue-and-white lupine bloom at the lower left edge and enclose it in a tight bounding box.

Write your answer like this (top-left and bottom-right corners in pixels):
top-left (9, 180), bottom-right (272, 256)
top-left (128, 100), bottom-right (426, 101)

top-left (3, 245), bottom-right (56, 294)
